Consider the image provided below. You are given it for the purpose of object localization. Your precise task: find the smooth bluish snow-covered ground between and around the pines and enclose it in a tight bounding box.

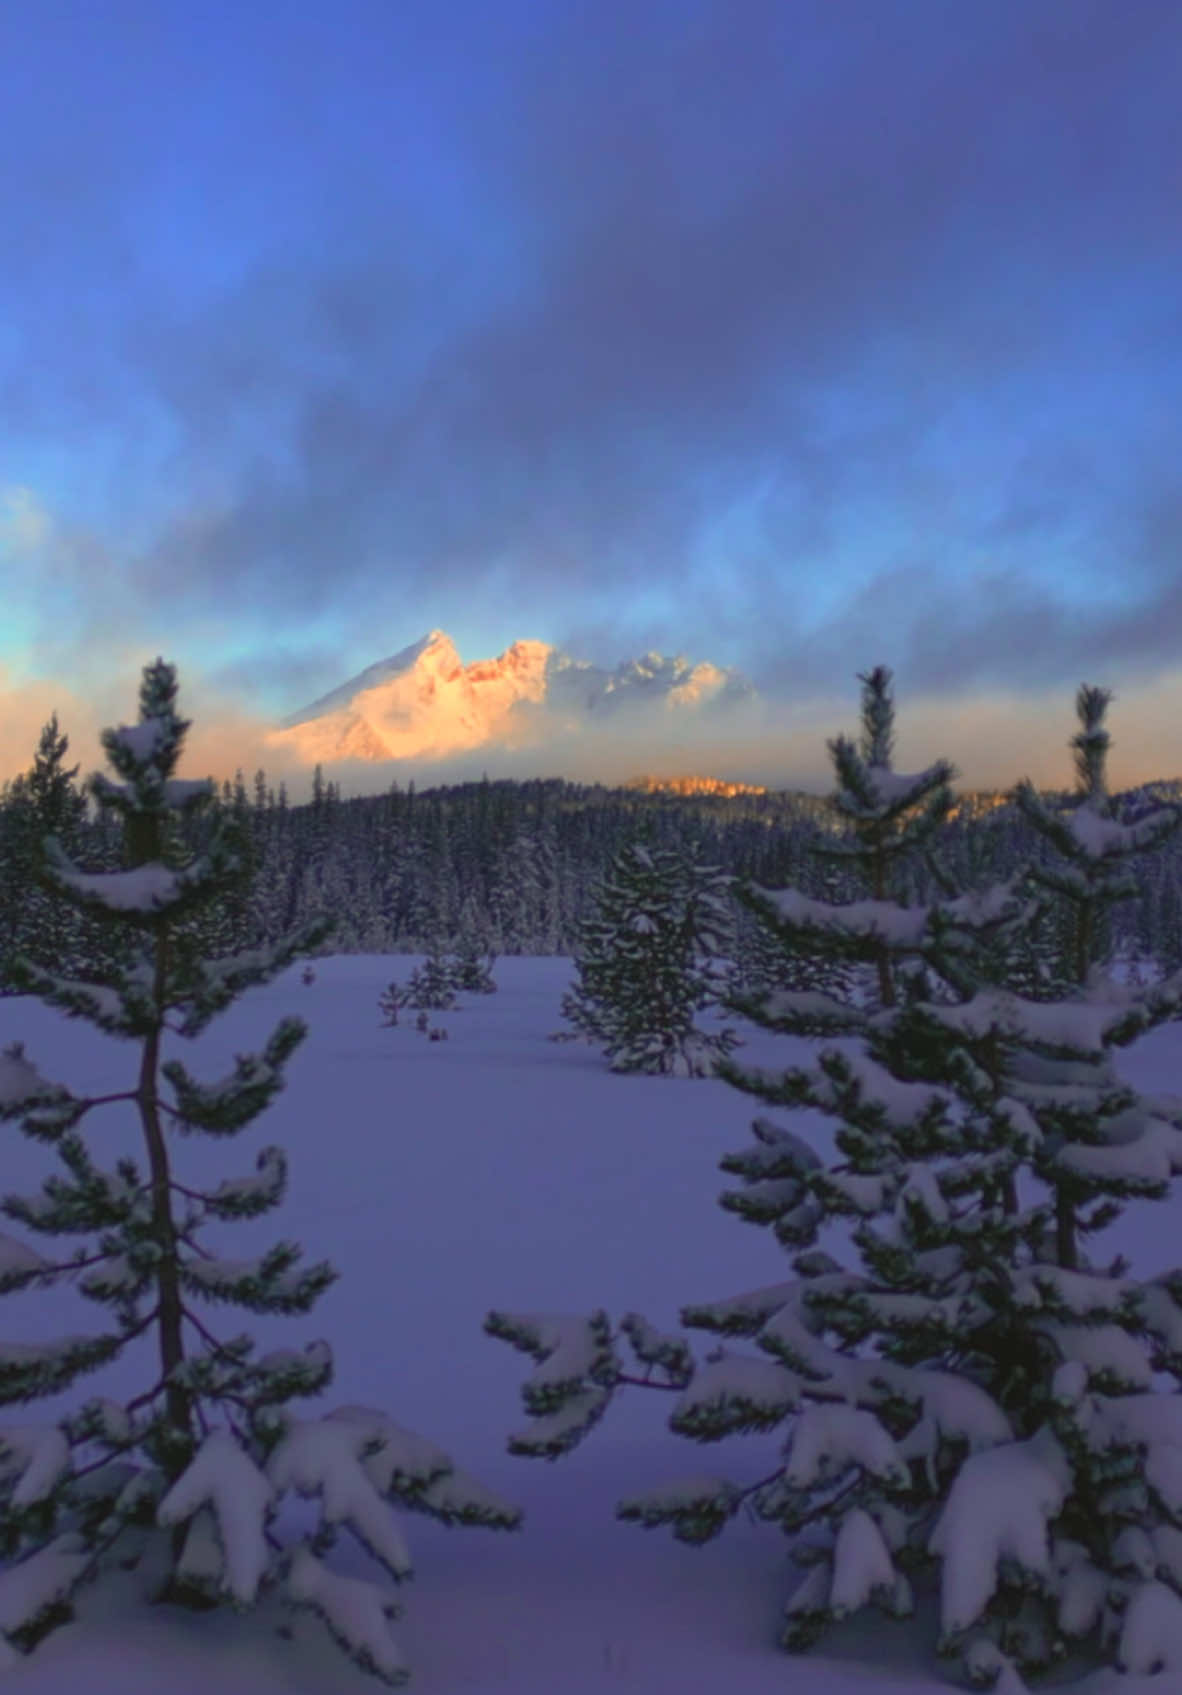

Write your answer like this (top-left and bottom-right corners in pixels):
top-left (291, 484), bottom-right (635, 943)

top-left (0, 956), bottom-right (1182, 1695)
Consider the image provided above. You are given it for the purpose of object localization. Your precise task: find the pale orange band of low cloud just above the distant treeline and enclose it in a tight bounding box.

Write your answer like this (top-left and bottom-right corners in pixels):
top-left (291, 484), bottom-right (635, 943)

top-left (0, 650), bottom-right (1182, 800)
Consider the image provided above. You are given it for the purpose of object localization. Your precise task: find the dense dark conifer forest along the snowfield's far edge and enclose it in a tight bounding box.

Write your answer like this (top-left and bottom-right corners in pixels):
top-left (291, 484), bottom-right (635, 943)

top-left (0, 725), bottom-right (1182, 973)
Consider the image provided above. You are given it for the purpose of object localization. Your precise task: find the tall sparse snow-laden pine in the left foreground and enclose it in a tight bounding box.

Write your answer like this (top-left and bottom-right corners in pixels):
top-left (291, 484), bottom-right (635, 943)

top-left (0, 661), bottom-right (519, 1683)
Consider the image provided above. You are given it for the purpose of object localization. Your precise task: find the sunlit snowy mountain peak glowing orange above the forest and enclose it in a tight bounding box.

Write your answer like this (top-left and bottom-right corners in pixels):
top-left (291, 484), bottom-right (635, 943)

top-left (268, 629), bottom-right (751, 764)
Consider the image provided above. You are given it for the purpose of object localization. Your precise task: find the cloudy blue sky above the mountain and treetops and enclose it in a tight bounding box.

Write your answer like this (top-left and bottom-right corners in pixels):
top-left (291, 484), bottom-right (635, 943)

top-left (0, 0), bottom-right (1182, 789)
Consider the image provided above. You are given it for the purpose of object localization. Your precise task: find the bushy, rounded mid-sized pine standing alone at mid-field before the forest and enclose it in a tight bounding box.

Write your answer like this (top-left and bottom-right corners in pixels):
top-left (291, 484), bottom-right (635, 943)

top-left (561, 841), bottom-right (736, 1076)
